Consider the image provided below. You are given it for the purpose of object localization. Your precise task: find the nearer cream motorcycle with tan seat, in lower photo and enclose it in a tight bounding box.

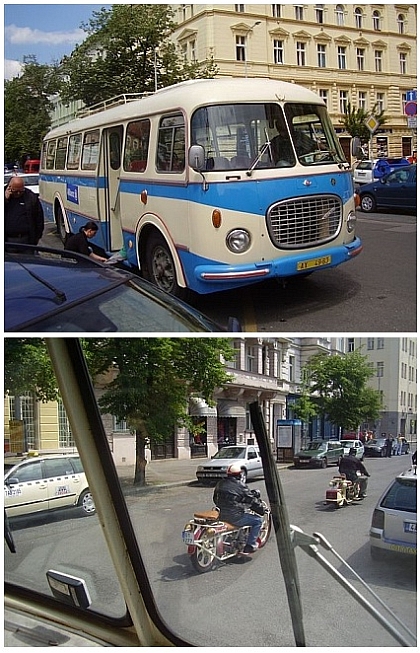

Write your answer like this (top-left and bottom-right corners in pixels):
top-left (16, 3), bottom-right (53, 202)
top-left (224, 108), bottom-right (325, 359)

top-left (182, 490), bottom-right (272, 574)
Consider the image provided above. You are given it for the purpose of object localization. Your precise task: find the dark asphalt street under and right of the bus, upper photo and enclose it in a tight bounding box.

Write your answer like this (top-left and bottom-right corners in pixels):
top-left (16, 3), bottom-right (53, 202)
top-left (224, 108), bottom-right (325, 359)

top-left (42, 211), bottom-right (417, 333)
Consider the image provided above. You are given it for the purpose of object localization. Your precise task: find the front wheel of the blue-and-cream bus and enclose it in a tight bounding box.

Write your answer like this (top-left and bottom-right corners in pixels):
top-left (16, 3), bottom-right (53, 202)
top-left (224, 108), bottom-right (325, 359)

top-left (146, 234), bottom-right (184, 298)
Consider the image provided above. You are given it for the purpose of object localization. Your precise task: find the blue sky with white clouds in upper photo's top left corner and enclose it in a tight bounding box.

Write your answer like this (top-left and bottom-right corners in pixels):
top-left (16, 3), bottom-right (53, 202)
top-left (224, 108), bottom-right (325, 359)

top-left (4, 3), bottom-right (110, 79)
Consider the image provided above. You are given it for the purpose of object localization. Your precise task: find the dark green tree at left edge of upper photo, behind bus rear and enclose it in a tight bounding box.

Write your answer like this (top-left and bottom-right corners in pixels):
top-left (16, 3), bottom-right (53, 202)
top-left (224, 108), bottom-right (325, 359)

top-left (4, 56), bottom-right (60, 165)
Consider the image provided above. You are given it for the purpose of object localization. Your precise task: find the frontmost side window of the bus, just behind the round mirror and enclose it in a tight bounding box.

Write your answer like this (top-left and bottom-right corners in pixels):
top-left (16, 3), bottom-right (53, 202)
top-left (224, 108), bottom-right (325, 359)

top-left (156, 113), bottom-right (185, 172)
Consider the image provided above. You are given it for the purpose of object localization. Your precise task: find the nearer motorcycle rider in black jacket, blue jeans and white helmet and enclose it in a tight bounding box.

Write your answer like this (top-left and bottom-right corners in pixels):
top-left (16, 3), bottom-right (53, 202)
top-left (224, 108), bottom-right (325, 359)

top-left (213, 463), bottom-right (264, 553)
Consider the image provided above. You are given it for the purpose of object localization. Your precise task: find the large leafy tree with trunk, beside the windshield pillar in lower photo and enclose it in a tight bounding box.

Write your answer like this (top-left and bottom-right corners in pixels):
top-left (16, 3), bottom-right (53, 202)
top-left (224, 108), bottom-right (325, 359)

top-left (84, 338), bottom-right (234, 485)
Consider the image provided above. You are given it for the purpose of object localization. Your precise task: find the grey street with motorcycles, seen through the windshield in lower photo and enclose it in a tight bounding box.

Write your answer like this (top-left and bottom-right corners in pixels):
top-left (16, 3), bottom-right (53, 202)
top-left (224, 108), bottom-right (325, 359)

top-left (5, 456), bottom-right (417, 647)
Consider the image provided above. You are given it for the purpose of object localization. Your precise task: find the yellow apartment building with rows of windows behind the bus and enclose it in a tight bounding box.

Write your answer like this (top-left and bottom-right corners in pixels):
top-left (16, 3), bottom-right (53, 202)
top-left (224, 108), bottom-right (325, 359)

top-left (173, 3), bottom-right (417, 160)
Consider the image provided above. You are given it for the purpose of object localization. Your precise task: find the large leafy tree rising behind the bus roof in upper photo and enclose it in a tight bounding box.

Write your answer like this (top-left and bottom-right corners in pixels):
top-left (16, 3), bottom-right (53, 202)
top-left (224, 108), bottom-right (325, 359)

top-left (61, 4), bottom-right (217, 106)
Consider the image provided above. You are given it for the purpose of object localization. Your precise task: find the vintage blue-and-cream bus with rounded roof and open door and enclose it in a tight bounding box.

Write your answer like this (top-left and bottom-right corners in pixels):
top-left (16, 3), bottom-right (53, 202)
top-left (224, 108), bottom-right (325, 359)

top-left (40, 79), bottom-right (362, 296)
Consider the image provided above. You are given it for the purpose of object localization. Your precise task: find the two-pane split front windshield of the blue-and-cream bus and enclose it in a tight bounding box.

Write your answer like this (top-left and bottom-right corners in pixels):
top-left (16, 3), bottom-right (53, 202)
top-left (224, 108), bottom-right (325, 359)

top-left (192, 104), bottom-right (345, 171)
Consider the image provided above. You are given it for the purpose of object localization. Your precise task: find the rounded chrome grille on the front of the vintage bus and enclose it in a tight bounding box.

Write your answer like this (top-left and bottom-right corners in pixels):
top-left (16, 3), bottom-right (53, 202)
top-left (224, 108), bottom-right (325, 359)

top-left (267, 195), bottom-right (342, 249)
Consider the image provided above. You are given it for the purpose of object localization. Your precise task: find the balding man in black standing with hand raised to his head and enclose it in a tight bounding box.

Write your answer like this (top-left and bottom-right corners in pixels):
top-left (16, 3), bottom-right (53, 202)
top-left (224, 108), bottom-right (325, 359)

top-left (4, 176), bottom-right (44, 252)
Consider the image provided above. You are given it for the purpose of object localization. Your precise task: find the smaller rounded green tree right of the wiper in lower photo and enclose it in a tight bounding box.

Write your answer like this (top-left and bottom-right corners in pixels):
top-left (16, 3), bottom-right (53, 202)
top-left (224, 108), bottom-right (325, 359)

top-left (298, 351), bottom-right (381, 430)
